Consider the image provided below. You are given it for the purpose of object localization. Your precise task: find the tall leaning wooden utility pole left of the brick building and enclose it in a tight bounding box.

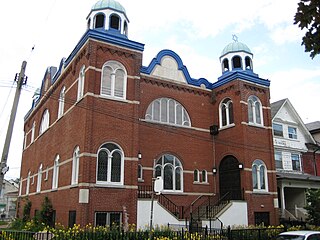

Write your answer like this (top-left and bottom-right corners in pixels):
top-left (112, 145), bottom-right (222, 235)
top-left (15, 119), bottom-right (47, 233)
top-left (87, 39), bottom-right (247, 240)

top-left (0, 61), bottom-right (27, 196)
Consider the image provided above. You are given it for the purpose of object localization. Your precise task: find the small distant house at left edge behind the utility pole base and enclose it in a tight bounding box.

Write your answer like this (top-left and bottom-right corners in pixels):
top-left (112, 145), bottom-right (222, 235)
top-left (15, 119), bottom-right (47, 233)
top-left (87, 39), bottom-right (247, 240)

top-left (0, 179), bottom-right (19, 218)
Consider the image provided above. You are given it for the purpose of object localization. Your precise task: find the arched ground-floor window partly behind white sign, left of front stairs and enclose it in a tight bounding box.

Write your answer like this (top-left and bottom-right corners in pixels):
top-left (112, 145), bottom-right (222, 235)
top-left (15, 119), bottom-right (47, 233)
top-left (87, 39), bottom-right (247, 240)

top-left (155, 154), bottom-right (183, 192)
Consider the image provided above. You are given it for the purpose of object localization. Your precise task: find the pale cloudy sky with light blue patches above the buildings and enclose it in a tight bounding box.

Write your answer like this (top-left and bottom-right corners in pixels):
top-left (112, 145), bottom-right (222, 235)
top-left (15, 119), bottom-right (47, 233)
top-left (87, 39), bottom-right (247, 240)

top-left (0, 0), bottom-right (320, 179)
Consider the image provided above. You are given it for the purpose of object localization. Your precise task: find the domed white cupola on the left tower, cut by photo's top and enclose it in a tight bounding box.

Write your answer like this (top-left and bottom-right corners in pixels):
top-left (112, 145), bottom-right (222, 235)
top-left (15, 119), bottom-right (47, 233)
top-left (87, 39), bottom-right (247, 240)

top-left (87, 0), bottom-right (129, 37)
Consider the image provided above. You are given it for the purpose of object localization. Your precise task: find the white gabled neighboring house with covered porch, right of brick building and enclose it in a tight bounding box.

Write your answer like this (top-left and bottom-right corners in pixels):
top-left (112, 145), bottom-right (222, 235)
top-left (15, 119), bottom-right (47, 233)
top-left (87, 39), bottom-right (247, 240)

top-left (271, 99), bottom-right (320, 220)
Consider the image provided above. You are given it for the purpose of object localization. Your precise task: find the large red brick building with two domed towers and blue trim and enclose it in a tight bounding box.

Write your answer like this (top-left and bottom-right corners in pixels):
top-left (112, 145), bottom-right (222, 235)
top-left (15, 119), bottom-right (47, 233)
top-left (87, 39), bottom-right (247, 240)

top-left (18, 0), bottom-right (278, 227)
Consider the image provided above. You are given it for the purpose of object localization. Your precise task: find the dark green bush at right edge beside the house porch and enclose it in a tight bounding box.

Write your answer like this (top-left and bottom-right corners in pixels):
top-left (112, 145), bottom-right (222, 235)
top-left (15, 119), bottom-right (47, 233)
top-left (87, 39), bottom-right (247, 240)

top-left (306, 189), bottom-right (320, 226)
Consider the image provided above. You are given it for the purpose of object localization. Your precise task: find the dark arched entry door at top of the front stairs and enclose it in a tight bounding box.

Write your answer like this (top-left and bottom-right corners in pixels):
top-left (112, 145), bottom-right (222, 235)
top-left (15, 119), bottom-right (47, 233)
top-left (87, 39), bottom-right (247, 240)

top-left (219, 156), bottom-right (242, 200)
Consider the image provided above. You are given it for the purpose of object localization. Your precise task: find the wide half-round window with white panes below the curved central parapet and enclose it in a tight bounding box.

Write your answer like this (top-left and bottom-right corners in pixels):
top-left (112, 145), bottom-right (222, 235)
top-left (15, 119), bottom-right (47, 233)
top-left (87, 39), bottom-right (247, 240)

top-left (145, 98), bottom-right (191, 127)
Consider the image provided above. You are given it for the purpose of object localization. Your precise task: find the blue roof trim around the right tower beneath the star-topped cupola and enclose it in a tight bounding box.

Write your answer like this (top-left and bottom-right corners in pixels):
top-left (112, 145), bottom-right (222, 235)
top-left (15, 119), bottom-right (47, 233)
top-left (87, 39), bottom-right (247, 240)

top-left (212, 70), bottom-right (270, 89)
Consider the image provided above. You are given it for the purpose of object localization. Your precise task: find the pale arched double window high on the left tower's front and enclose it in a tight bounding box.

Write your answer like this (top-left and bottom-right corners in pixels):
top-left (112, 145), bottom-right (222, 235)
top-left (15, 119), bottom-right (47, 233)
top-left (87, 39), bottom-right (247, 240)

top-left (101, 61), bottom-right (127, 99)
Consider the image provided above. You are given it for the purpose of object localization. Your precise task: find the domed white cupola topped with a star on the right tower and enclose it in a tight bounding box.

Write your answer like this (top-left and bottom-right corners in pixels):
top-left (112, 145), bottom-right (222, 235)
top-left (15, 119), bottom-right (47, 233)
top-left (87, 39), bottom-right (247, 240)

top-left (220, 35), bottom-right (253, 74)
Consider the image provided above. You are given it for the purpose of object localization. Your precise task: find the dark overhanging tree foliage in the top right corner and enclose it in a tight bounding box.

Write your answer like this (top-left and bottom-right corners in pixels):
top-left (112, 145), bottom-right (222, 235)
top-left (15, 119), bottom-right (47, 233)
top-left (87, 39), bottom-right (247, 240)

top-left (294, 0), bottom-right (320, 59)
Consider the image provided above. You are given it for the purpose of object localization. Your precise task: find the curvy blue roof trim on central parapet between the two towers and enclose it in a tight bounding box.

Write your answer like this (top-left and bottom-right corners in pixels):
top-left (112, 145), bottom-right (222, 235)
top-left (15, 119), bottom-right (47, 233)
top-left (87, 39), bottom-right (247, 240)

top-left (140, 49), bottom-right (212, 89)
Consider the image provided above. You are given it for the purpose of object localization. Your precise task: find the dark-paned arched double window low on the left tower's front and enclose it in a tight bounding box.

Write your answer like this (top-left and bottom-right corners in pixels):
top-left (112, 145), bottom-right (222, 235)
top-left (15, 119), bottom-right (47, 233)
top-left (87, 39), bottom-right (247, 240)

top-left (97, 143), bottom-right (124, 185)
